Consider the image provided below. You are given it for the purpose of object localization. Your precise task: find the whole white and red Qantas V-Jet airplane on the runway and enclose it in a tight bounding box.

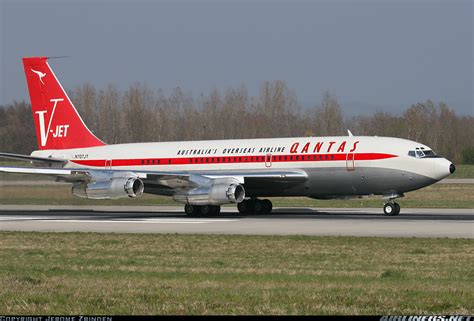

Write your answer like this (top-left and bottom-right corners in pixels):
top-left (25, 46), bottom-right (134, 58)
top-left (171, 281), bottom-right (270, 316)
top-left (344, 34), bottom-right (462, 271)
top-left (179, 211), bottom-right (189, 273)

top-left (0, 57), bottom-right (455, 216)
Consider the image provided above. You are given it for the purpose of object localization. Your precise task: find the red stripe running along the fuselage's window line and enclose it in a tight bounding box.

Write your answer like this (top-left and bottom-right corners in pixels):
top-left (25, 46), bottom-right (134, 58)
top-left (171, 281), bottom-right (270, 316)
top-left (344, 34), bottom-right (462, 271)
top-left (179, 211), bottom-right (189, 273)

top-left (71, 153), bottom-right (397, 167)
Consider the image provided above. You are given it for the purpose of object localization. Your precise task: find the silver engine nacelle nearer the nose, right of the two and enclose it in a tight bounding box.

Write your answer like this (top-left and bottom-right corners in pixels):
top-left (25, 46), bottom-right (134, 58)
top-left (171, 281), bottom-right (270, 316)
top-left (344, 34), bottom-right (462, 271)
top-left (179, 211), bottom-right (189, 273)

top-left (173, 184), bottom-right (245, 205)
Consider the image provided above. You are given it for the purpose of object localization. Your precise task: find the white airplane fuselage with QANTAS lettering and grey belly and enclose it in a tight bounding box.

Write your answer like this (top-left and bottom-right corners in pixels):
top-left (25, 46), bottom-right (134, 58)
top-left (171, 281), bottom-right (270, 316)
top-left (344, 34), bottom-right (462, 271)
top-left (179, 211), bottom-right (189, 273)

top-left (32, 136), bottom-right (451, 197)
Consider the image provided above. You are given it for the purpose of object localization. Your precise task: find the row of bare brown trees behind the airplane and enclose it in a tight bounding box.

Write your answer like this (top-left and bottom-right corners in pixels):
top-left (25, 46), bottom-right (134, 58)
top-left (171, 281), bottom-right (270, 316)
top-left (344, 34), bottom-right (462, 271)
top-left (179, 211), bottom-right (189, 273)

top-left (0, 80), bottom-right (474, 162)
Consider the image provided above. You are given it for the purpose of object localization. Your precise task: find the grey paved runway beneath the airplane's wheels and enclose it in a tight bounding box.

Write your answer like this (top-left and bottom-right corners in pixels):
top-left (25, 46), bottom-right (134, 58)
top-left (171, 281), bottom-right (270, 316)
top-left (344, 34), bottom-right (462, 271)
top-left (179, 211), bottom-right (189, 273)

top-left (0, 205), bottom-right (474, 239)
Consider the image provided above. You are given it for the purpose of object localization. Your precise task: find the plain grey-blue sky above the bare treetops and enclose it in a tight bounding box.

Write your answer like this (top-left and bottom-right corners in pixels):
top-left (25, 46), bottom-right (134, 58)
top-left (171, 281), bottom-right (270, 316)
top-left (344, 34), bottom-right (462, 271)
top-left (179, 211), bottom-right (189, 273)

top-left (0, 0), bottom-right (474, 115)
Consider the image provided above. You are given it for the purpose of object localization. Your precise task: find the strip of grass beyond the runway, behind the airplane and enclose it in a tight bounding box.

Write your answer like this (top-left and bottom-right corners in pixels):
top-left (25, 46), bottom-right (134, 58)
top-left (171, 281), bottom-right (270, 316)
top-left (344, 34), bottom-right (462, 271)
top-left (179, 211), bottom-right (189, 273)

top-left (0, 184), bottom-right (474, 208)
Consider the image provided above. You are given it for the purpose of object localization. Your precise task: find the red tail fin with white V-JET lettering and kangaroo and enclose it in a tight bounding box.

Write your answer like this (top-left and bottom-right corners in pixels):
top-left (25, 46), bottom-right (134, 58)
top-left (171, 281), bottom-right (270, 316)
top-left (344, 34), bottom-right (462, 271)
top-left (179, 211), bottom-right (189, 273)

top-left (23, 57), bottom-right (105, 149)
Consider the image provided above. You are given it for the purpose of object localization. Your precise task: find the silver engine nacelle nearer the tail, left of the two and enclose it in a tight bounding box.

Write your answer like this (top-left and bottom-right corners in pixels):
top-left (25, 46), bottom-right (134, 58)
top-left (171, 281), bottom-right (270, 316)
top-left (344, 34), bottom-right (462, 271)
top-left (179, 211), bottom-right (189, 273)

top-left (72, 177), bottom-right (145, 199)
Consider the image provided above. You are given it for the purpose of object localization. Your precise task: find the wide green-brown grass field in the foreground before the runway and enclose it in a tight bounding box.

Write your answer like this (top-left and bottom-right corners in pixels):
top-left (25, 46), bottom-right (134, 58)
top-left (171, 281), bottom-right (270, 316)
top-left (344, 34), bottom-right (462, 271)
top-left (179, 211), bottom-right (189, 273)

top-left (0, 232), bottom-right (474, 315)
